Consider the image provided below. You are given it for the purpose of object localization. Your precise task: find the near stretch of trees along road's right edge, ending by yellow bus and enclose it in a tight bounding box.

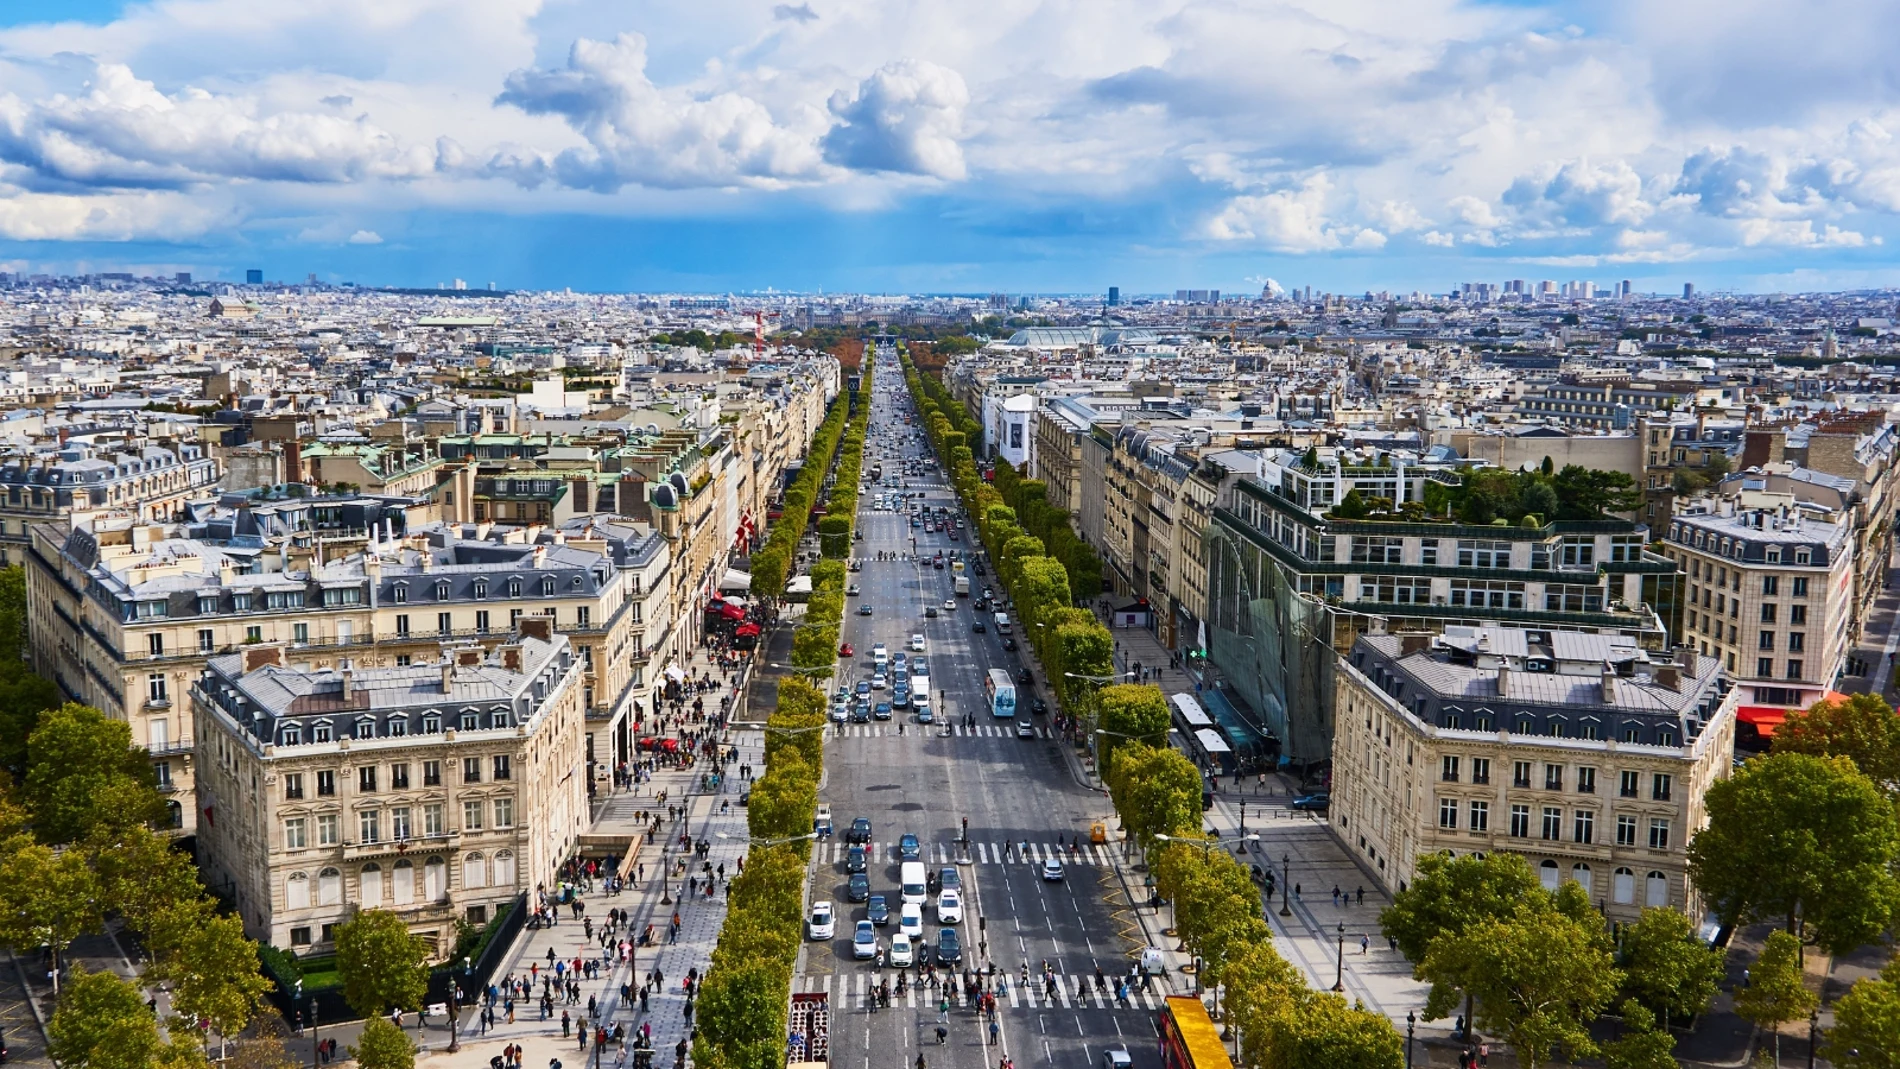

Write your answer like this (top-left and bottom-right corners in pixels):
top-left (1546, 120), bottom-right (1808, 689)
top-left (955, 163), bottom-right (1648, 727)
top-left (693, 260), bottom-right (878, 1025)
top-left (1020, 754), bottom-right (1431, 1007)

top-left (1100, 684), bottom-right (1404, 1069)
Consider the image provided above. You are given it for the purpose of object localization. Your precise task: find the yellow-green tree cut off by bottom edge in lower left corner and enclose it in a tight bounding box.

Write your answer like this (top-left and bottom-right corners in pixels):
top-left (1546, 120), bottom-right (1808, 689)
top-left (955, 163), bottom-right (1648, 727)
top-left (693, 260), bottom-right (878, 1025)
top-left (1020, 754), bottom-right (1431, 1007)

top-left (46, 966), bottom-right (203, 1069)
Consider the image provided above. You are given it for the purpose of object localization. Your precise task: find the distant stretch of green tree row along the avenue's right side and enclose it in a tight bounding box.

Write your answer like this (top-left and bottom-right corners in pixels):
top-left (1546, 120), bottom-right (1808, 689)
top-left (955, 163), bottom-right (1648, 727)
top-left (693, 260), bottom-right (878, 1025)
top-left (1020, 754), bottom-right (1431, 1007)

top-left (904, 355), bottom-right (1115, 740)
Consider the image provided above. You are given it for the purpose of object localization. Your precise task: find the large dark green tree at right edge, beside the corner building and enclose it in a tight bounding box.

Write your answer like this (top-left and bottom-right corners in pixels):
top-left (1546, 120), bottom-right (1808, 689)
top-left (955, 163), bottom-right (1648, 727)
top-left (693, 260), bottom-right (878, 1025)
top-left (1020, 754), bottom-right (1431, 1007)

top-left (1689, 754), bottom-right (1900, 953)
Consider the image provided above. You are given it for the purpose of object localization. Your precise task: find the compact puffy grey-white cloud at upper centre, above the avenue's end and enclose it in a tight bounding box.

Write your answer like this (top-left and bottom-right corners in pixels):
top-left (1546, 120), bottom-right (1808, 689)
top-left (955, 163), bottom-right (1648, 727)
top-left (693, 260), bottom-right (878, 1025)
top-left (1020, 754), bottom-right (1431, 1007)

top-left (825, 59), bottom-right (969, 180)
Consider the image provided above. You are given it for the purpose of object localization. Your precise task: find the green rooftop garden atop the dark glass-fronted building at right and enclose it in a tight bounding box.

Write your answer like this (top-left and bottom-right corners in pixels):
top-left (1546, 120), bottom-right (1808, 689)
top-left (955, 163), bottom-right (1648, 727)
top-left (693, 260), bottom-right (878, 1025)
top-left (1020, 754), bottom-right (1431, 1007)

top-left (1309, 454), bottom-right (1644, 528)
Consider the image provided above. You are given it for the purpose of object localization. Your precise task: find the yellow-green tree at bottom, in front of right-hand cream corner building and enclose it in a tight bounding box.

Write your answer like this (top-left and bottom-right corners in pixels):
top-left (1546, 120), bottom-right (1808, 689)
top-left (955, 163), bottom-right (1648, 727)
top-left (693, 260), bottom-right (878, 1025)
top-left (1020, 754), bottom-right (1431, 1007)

top-left (1419, 903), bottom-right (1621, 1069)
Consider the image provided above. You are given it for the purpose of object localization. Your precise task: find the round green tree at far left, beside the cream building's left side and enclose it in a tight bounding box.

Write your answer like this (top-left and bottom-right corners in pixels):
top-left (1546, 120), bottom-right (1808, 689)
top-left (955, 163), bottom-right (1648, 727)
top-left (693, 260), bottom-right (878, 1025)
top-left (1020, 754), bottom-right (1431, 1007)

top-left (25, 703), bottom-right (165, 845)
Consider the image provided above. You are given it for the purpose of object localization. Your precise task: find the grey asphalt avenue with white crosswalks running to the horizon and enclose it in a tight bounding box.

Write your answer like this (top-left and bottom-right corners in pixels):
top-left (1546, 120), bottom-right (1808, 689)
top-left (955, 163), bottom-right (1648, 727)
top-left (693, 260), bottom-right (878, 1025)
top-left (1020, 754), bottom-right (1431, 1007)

top-left (792, 353), bottom-right (1161, 1069)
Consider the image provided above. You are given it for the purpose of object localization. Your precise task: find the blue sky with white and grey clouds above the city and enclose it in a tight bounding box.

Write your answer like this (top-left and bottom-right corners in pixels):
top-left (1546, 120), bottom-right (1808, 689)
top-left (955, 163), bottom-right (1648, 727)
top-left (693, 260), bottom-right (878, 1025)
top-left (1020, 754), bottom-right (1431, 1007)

top-left (0, 0), bottom-right (1900, 294)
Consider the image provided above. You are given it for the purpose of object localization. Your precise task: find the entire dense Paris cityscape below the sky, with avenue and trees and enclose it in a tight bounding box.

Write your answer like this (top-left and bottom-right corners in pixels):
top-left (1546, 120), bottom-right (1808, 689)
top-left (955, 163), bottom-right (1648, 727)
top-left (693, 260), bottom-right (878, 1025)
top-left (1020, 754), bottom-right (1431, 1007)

top-left (0, 270), bottom-right (1900, 1069)
